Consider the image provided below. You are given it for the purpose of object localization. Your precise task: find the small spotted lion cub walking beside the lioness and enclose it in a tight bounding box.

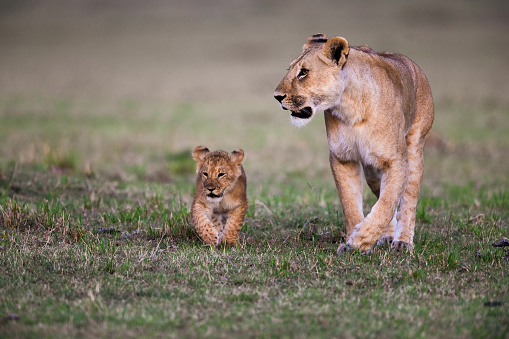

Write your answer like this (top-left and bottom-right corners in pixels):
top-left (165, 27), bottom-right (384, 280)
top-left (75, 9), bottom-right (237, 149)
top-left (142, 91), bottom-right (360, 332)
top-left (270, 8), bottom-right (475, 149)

top-left (191, 146), bottom-right (247, 246)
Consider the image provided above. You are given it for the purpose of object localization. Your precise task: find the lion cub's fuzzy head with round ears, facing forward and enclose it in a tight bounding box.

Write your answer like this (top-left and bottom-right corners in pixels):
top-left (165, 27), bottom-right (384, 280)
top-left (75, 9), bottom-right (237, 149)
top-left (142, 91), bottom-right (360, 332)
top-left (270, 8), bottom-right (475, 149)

top-left (193, 146), bottom-right (244, 201)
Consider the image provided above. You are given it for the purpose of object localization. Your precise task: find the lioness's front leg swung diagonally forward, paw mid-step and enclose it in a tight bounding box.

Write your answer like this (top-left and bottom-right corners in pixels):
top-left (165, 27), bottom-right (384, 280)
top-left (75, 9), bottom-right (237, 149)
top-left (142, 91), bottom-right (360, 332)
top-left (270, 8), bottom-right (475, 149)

top-left (347, 160), bottom-right (408, 251)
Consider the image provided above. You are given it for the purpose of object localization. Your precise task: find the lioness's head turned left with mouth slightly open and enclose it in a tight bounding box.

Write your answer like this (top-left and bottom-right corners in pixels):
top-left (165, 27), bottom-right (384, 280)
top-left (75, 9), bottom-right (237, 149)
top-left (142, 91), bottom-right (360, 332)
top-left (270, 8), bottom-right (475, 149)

top-left (274, 34), bottom-right (349, 127)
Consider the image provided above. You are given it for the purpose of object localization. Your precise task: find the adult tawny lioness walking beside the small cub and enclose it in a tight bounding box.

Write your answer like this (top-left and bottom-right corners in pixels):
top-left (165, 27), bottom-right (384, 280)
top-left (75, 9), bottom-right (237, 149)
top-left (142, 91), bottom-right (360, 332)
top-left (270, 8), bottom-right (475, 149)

top-left (274, 34), bottom-right (434, 253)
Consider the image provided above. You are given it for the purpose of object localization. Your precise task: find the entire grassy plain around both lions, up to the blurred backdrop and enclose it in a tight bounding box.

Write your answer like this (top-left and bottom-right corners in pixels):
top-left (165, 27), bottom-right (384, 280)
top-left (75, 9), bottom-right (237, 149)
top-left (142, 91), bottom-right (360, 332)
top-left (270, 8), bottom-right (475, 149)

top-left (0, 0), bottom-right (509, 338)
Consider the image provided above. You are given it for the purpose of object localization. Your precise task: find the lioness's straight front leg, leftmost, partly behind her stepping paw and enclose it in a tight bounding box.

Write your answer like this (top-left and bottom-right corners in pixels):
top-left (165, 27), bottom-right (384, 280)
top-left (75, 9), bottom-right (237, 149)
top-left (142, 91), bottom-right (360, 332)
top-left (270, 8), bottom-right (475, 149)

top-left (329, 153), bottom-right (364, 239)
